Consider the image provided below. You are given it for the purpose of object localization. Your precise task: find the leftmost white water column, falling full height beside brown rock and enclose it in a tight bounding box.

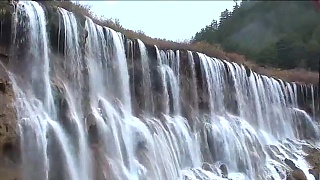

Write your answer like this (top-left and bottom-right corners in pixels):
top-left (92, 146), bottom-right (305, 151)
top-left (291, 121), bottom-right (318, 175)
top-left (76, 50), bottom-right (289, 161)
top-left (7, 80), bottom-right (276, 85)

top-left (10, 2), bottom-right (76, 179)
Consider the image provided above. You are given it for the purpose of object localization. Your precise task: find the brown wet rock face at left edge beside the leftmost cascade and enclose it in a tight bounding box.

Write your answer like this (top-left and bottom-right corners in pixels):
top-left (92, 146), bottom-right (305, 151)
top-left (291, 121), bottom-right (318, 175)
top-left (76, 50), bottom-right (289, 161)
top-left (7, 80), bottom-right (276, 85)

top-left (0, 65), bottom-right (21, 180)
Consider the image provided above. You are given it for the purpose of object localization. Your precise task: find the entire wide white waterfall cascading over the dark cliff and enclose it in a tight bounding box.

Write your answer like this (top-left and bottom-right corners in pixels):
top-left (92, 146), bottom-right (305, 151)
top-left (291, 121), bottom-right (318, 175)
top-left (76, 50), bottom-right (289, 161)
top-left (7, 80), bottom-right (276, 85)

top-left (7, 1), bottom-right (320, 180)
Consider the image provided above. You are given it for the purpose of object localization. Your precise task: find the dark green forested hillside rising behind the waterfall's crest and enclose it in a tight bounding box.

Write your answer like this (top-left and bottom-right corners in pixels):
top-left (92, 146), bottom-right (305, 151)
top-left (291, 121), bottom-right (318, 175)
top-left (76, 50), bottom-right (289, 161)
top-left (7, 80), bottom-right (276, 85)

top-left (192, 1), bottom-right (320, 71)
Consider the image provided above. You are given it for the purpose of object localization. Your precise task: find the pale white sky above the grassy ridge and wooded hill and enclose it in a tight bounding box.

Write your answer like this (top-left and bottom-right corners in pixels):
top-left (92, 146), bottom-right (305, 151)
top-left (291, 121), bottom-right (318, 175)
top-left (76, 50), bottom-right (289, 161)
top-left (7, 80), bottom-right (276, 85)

top-left (79, 0), bottom-right (235, 41)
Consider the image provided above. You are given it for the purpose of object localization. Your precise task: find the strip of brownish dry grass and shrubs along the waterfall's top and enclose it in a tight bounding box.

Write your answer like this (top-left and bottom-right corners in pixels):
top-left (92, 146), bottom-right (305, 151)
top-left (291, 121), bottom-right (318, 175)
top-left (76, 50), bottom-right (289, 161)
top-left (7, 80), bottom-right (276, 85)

top-left (57, 1), bottom-right (319, 84)
